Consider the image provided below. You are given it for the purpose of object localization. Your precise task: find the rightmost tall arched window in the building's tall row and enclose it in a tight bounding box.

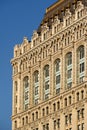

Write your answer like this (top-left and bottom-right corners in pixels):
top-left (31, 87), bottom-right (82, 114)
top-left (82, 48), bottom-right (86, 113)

top-left (77, 45), bottom-right (85, 83)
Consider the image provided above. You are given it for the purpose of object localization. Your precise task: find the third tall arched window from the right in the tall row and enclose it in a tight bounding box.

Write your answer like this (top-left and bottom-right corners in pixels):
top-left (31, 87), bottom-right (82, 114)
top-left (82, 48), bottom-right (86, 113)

top-left (55, 59), bottom-right (61, 94)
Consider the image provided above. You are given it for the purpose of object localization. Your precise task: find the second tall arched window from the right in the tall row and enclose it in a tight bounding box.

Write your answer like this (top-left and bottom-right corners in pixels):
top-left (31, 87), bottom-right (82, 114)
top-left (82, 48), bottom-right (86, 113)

top-left (65, 52), bottom-right (72, 88)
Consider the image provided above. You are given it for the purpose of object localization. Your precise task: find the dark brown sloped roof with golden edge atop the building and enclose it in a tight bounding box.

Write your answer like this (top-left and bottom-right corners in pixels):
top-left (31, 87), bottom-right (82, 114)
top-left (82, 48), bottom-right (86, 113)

top-left (37, 0), bottom-right (87, 33)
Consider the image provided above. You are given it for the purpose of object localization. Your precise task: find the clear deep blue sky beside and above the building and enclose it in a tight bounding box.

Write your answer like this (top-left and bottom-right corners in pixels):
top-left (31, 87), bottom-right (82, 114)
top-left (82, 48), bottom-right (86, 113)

top-left (0, 0), bottom-right (57, 130)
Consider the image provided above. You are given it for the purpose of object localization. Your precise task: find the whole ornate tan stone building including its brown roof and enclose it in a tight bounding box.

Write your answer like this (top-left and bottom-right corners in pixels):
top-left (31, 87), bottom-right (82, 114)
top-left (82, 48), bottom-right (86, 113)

top-left (11, 0), bottom-right (87, 130)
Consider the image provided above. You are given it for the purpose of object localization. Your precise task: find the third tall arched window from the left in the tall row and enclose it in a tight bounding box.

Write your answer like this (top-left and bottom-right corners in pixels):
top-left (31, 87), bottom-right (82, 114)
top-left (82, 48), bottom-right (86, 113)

top-left (43, 65), bottom-right (50, 100)
